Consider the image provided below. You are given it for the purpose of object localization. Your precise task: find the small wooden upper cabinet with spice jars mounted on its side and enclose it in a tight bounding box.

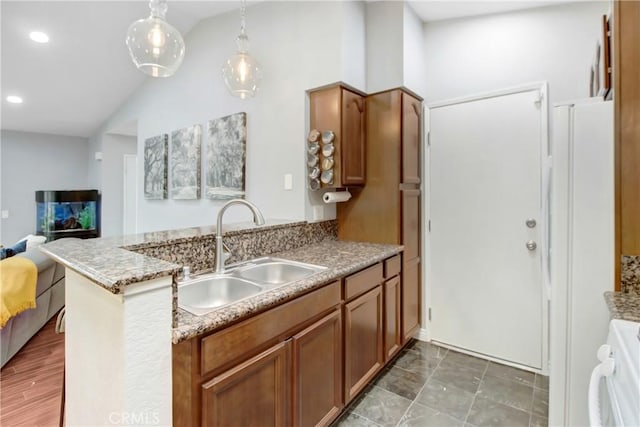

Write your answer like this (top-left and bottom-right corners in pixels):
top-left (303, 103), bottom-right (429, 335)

top-left (309, 84), bottom-right (366, 188)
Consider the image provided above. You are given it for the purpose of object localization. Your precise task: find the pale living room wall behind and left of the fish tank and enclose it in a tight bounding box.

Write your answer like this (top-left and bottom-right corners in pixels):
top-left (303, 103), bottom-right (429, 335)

top-left (0, 130), bottom-right (89, 246)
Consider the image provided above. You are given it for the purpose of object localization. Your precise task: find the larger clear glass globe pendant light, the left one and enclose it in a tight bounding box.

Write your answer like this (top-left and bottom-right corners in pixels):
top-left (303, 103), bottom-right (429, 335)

top-left (126, 0), bottom-right (184, 77)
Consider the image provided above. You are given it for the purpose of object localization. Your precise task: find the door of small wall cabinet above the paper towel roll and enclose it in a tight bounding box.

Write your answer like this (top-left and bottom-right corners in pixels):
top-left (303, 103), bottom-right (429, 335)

top-left (340, 89), bottom-right (365, 186)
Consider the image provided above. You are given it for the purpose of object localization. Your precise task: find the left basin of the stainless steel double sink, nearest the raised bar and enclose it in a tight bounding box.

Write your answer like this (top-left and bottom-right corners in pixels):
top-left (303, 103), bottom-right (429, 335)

top-left (178, 276), bottom-right (263, 315)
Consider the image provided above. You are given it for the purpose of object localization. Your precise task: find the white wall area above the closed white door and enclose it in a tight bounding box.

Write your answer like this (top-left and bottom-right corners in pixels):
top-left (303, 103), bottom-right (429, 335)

top-left (424, 1), bottom-right (609, 105)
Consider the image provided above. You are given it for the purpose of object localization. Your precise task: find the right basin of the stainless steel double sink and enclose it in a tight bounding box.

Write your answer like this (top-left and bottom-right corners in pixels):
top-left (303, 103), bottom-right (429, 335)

top-left (232, 258), bottom-right (326, 285)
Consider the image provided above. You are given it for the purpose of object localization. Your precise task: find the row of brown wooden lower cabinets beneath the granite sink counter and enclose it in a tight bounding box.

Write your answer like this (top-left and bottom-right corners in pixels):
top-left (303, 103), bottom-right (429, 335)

top-left (172, 255), bottom-right (410, 427)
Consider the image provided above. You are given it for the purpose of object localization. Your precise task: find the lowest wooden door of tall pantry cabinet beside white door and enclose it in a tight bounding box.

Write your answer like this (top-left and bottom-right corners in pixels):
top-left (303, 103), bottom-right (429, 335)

top-left (402, 258), bottom-right (421, 342)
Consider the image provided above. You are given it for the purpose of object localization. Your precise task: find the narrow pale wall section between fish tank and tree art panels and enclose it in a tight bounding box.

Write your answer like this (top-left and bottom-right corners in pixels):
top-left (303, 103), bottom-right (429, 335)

top-left (101, 134), bottom-right (138, 236)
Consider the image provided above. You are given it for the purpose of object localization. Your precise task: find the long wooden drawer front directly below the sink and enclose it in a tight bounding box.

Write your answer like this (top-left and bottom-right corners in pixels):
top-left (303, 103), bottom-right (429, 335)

top-left (201, 281), bottom-right (340, 376)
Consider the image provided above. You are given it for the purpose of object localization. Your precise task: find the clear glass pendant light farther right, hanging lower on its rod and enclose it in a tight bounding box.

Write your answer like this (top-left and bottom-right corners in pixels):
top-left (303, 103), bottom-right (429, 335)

top-left (222, 0), bottom-right (262, 99)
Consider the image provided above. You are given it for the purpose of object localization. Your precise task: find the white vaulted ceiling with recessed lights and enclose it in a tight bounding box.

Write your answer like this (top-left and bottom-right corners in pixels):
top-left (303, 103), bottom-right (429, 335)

top-left (0, 0), bottom-right (559, 137)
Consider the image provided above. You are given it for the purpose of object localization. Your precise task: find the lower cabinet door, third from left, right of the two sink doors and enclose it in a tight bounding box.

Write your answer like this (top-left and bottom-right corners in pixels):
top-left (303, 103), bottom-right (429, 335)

top-left (344, 285), bottom-right (384, 403)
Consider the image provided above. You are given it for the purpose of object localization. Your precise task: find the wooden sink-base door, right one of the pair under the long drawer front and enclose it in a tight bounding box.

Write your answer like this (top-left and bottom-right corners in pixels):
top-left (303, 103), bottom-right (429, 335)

top-left (293, 308), bottom-right (343, 427)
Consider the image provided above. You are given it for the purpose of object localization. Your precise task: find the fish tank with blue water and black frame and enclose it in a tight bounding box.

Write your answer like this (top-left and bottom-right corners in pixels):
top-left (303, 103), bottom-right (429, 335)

top-left (36, 190), bottom-right (100, 241)
